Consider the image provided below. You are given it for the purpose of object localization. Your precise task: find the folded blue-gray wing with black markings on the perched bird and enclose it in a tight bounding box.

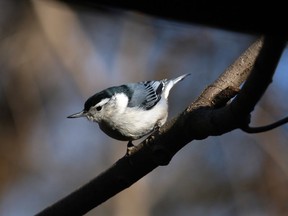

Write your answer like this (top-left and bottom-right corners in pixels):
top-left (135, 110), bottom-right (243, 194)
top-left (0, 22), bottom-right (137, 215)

top-left (128, 81), bottom-right (163, 110)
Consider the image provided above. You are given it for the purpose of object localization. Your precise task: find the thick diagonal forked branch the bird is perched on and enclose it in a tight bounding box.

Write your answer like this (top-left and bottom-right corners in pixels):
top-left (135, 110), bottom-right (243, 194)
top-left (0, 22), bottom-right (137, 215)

top-left (37, 38), bottom-right (285, 216)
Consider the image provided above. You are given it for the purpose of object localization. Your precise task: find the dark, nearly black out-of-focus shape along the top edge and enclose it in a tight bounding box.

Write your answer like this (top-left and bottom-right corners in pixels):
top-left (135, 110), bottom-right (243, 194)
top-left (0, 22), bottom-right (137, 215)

top-left (58, 0), bottom-right (288, 38)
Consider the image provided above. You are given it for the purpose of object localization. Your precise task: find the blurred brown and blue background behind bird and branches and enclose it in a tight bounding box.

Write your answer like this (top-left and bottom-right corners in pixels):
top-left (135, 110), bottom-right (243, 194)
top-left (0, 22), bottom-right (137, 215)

top-left (0, 0), bottom-right (288, 216)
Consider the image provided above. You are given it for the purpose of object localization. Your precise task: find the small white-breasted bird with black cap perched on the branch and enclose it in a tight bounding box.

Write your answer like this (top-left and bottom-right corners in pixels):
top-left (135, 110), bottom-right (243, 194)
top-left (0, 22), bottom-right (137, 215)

top-left (67, 73), bottom-right (190, 154)
